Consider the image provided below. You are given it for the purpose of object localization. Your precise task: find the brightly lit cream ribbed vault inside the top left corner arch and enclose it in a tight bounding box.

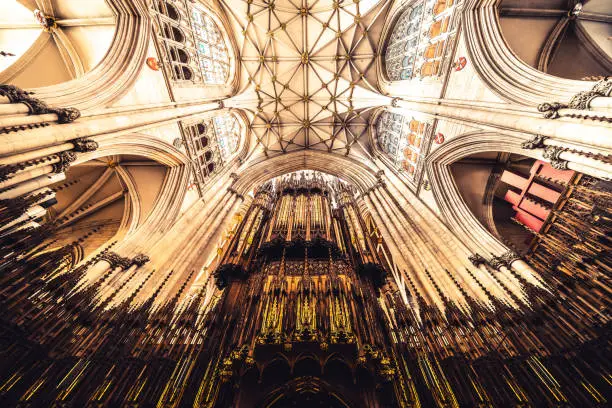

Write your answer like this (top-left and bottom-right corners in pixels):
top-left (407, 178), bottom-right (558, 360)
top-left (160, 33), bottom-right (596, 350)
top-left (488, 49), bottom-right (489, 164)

top-left (0, 0), bottom-right (116, 88)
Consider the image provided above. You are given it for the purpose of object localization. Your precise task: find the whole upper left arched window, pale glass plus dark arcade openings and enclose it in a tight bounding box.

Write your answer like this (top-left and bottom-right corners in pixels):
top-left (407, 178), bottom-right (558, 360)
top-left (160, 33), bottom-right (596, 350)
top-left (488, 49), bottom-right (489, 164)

top-left (154, 0), bottom-right (230, 85)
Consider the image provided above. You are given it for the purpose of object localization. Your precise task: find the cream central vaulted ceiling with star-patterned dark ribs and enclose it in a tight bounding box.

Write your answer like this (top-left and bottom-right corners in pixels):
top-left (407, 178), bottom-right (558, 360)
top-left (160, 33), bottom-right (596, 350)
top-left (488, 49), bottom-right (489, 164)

top-left (221, 0), bottom-right (390, 155)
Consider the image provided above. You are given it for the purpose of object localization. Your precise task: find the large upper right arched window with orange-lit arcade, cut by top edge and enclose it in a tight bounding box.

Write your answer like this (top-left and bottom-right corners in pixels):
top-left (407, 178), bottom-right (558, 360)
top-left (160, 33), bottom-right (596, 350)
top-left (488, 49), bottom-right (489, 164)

top-left (385, 0), bottom-right (457, 81)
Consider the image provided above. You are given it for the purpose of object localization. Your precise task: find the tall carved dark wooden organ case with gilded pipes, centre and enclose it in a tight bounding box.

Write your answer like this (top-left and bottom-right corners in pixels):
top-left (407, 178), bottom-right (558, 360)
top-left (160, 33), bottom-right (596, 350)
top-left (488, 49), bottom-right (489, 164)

top-left (210, 173), bottom-right (397, 407)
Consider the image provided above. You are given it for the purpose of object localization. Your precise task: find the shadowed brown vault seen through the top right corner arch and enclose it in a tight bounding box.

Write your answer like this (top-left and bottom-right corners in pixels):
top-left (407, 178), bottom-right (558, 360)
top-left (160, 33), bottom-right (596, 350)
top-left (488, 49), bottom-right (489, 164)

top-left (498, 0), bottom-right (612, 79)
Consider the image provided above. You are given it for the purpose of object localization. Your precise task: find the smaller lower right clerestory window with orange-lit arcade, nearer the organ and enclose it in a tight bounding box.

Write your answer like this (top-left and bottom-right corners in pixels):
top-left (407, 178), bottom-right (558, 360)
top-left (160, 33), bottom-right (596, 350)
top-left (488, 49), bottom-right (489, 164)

top-left (376, 111), bottom-right (429, 176)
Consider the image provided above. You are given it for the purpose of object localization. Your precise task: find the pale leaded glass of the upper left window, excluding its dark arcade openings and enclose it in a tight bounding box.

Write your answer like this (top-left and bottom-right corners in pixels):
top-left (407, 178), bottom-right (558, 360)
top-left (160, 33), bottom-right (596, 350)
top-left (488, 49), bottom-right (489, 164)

top-left (191, 8), bottom-right (230, 85)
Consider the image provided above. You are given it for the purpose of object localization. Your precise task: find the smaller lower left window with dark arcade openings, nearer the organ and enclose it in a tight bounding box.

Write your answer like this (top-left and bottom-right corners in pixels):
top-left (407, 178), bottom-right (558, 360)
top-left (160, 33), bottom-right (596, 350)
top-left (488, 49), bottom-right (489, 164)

top-left (183, 113), bottom-right (243, 194)
